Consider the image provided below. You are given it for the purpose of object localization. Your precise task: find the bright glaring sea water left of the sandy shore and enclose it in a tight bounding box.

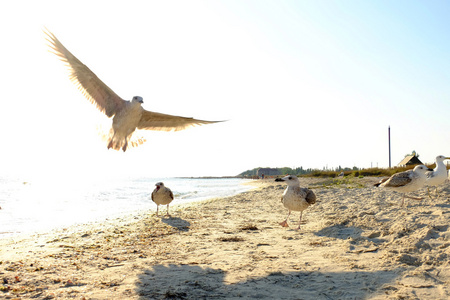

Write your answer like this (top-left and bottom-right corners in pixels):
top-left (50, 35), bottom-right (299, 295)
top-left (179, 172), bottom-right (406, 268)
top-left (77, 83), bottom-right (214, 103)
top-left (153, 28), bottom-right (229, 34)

top-left (0, 177), bottom-right (251, 238)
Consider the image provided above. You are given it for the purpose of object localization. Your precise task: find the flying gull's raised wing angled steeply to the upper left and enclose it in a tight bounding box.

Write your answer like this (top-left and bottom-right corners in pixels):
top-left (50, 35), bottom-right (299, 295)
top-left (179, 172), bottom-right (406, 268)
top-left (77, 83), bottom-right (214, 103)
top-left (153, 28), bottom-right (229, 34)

top-left (44, 31), bottom-right (125, 117)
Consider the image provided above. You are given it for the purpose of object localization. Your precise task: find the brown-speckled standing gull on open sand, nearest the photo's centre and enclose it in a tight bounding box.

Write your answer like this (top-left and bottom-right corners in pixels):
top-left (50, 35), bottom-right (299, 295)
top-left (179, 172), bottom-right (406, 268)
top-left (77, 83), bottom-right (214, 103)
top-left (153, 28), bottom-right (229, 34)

top-left (275, 175), bottom-right (316, 229)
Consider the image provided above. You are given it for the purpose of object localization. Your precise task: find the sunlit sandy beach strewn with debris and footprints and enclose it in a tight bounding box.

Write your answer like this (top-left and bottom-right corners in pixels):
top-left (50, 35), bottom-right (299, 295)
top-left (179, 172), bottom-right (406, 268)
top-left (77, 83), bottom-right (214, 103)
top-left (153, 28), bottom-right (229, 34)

top-left (0, 178), bottom-right (450, 300)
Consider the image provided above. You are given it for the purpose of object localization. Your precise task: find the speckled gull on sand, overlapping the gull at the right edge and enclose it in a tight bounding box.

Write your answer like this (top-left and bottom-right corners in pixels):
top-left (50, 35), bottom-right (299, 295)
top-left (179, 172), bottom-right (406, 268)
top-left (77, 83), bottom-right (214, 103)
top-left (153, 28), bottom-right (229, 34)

top-left (375, 165), bottom-right (433, 206)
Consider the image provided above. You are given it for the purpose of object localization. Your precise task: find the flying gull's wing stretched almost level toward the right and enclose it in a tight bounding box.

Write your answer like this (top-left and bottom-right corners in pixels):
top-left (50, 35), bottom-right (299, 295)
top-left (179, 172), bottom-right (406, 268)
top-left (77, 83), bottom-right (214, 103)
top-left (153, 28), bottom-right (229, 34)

top-left (137, 110), bottom-right (222, 131)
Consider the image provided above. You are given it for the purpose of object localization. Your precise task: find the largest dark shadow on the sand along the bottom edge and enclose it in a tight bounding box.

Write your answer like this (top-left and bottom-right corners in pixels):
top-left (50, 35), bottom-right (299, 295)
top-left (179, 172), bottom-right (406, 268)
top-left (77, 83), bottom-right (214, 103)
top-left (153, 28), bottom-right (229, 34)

top-left (136, 264), bottom-right (397, 300)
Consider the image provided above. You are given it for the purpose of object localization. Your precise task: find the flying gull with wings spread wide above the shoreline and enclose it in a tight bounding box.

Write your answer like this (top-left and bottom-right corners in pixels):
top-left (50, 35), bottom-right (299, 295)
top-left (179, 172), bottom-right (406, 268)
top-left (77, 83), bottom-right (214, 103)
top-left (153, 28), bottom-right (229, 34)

top-left (44, 31), bottom-right (220, 152)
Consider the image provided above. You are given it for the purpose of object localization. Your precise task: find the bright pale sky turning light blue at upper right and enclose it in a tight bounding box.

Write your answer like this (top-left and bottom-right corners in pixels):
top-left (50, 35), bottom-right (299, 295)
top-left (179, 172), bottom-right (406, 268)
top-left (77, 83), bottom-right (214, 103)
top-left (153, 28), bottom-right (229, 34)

top-left (0, 0), bottom-right (450, 177)
